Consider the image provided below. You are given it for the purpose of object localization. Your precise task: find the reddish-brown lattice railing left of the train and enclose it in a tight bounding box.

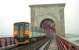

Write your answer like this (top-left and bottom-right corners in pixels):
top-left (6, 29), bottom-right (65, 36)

top-left (0, 37), bottom-right (16, 50)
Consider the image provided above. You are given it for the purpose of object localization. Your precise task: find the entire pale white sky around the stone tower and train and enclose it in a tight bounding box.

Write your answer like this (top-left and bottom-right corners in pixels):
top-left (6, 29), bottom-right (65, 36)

top-left (0, 0), bottom-right (79, 36)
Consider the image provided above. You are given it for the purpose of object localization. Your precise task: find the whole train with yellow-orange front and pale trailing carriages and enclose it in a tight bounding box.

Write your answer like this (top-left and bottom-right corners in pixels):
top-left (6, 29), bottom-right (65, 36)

top-left (14, 22), bottom-right (46, 45)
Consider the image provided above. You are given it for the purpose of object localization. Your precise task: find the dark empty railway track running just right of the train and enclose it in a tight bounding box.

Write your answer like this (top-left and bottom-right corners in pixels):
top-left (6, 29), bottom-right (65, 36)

top-left (8, 38), bottom-right (48, 50)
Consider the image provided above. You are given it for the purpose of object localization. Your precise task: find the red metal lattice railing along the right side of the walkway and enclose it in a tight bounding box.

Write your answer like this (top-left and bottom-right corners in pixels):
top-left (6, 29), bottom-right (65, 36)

top-left (56, 34), bottom-right (79, 50)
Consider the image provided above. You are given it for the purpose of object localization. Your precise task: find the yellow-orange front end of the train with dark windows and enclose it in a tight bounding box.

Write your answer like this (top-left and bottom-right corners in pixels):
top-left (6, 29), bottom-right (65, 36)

top-left (14, 22), bottom-right (32, 45)
